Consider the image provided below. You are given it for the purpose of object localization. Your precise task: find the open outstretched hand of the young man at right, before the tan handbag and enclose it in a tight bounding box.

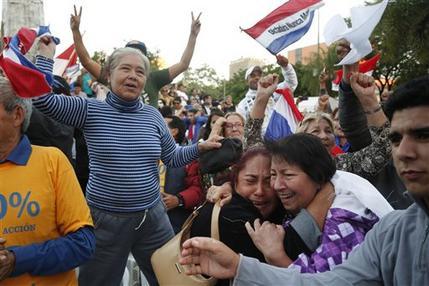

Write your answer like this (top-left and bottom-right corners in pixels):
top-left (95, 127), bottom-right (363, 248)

top-left (179, 237), bottom-right (240, 279)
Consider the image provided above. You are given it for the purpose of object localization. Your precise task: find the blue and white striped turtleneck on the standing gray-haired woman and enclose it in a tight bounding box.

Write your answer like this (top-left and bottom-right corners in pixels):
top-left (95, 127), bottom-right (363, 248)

top-left (33, 57), bottom-right (198, 212)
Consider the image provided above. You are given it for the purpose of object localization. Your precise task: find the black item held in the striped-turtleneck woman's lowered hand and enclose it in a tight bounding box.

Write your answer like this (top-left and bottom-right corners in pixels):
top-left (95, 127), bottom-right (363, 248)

top-left (200, 138), bottom-right (243, 174)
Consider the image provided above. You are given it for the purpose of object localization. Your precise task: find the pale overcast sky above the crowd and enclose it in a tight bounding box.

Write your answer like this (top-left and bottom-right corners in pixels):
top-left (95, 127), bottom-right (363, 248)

top-left (0, 0), bottom-right (364, 77)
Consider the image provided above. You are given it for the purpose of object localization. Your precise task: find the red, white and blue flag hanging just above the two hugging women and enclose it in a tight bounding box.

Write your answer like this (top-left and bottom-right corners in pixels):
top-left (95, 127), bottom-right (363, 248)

top-left (265, 89), bottom-right (303, 141)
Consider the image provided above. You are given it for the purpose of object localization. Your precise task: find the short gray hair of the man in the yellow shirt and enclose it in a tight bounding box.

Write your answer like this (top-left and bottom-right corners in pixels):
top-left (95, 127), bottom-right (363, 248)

top-left (0, 76), bottom-right (33, 134)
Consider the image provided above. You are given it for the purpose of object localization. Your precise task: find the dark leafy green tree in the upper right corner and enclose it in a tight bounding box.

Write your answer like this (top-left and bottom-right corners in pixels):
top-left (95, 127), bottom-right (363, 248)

top-left (369, 0), bottom-right (429, 94)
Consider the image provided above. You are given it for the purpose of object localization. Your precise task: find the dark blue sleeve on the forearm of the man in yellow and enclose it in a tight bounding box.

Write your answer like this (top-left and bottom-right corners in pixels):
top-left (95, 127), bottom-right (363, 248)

top-left (9, 226), bottom-right (95, 277)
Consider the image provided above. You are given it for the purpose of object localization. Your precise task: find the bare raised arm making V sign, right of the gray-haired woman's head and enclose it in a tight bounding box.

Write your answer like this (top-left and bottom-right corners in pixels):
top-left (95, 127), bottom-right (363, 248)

top-left (168, 13), bottom-right (201, 81)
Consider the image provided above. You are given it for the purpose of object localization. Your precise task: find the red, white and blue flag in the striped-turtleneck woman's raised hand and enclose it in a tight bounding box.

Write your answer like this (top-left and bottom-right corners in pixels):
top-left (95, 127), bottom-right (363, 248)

top-left (0, 26), bottom-right (60, 98)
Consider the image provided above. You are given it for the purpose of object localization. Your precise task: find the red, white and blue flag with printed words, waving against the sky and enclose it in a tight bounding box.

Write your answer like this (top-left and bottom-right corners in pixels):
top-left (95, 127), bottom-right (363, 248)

top-left (243, 0), bottom-right (323, 55)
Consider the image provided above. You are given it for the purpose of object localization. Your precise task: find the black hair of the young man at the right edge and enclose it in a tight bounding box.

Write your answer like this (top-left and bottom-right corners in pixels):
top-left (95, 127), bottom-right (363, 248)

top-left (384, 75), bottom-right (429, 120)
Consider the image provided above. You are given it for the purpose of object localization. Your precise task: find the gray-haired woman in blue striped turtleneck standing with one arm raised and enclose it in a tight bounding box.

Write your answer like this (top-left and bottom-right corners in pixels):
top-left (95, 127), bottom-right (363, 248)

top-left (34, 38), bottom-right (220, 285)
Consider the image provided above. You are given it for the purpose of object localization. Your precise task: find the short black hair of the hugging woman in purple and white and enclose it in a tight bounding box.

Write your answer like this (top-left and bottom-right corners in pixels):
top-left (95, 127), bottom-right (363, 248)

top-left (265, 133), bottom-right (336, 185)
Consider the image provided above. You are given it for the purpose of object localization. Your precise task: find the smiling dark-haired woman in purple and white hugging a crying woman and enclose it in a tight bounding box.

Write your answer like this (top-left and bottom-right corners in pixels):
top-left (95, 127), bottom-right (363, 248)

top-left (247, 133), bottom-right (393, 273)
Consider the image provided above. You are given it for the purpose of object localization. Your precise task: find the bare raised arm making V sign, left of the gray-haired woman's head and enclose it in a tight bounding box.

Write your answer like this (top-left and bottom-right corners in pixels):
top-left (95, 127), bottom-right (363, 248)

top-left (70, 6), bottom-right (101, 79)
